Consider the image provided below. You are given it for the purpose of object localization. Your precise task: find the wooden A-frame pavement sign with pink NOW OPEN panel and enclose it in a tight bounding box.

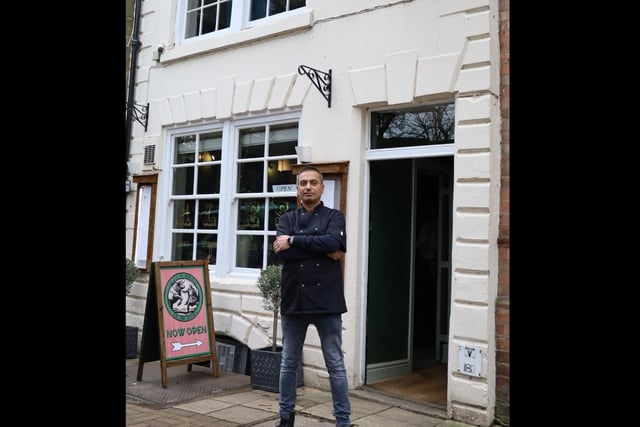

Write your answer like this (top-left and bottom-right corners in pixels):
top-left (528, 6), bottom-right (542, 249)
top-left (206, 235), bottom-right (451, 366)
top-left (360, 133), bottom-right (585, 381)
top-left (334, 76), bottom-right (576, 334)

top-left (137, 260), bottom-right (219, 388)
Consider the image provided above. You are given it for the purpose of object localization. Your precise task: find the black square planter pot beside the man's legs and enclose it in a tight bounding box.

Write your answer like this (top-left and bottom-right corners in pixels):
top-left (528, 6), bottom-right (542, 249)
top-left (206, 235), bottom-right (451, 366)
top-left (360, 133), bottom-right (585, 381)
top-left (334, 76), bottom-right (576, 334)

top-left (251, 346), bottom-right (304, 393)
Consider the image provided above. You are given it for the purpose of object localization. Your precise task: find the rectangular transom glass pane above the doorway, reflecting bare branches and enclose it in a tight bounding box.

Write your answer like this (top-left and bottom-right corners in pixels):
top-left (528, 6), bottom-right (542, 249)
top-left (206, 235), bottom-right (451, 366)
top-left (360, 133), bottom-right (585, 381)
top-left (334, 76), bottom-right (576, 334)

top-left (371, 103), bottom-right (455, 148)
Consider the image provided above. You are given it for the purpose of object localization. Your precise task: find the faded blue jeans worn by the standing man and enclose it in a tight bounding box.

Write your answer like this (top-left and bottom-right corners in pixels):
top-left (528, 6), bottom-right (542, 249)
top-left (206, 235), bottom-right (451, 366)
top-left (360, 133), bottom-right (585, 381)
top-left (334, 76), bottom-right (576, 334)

top-left (280, 314), bottom-right (351, 427)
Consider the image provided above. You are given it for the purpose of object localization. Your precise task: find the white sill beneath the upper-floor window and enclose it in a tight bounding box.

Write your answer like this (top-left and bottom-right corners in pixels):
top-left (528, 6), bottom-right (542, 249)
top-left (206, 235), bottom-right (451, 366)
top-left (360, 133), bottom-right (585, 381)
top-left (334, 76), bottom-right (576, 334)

top-left (160, 9), bottom-right (313, 64)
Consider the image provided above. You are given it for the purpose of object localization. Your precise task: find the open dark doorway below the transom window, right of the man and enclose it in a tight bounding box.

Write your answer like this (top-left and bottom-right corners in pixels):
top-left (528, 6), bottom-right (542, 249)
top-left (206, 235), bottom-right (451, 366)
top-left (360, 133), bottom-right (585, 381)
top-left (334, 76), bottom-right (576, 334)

top-left (365, 156), bottom-right (453, 404)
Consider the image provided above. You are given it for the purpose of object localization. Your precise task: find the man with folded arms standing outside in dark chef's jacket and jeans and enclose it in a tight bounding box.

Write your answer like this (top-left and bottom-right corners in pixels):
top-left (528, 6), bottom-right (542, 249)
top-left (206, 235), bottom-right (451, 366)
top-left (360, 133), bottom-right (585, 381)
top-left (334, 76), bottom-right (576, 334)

top-left (273, 166), bottom-right (351, 427)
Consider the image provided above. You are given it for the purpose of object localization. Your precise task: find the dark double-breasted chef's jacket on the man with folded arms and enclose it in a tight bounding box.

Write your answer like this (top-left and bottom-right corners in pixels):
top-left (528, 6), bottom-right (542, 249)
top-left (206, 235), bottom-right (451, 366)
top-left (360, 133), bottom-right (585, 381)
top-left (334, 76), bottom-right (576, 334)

top-left (276, 202), bottom-right (347, 316)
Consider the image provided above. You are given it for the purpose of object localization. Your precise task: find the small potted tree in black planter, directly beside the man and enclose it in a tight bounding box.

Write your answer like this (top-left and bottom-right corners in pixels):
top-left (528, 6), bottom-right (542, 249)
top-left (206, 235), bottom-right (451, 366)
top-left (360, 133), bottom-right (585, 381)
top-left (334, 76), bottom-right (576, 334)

top-left (251, 264), bottom-right (304, 393)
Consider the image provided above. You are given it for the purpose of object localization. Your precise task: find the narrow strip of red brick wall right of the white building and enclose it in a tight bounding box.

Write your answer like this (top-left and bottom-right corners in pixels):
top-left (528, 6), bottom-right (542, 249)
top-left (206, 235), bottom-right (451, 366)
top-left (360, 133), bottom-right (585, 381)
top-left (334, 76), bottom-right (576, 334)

top-left (495, 0), bottom-right (510, 426)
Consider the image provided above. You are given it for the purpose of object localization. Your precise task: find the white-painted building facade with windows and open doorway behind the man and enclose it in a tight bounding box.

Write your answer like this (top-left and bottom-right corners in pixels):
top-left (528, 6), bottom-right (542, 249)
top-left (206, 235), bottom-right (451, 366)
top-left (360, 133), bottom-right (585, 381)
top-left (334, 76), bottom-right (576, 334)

top-left (126, 0), bottom-right (509, 426)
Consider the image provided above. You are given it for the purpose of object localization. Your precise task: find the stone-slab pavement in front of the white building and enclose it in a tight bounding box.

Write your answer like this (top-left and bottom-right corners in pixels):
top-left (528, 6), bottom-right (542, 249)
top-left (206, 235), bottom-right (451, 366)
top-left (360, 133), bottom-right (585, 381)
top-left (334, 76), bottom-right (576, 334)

top-left (125, 359), bottom-right (471, 427)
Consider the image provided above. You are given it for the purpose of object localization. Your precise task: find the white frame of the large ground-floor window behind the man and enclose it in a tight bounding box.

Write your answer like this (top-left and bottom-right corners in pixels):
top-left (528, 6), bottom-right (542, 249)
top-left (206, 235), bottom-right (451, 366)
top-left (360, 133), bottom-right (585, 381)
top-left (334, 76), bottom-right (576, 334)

top-left (157, 111), bottom-right (302, 278)
